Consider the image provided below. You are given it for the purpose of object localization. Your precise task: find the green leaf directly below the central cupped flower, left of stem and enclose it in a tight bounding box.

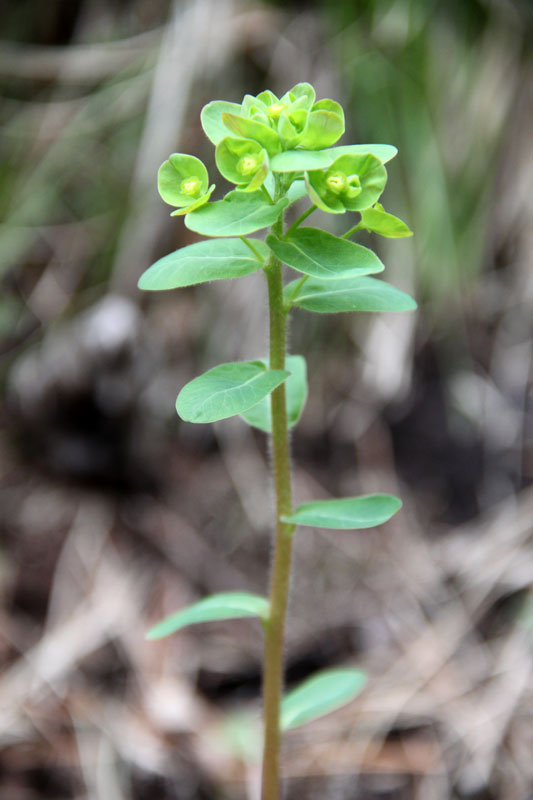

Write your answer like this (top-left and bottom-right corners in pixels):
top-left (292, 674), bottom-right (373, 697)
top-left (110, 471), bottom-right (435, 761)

top-left (185, 190), bottom-right (289, 236)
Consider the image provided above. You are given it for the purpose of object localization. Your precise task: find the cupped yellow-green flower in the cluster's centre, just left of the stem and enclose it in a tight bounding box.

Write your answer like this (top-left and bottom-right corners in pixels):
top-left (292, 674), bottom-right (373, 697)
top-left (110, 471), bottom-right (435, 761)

top-left (215, 136), bottom-right (268, 192)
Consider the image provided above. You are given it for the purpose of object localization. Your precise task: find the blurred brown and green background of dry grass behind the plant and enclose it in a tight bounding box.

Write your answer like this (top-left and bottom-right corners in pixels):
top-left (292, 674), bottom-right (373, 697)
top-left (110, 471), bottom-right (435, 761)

top-left (0, 0), bottom-right (533, 800)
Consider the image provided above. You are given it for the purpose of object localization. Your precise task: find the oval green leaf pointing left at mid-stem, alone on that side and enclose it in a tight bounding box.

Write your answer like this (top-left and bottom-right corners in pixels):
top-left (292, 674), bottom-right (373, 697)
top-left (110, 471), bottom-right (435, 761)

top-left (176, 361), bottom-right (290, 422)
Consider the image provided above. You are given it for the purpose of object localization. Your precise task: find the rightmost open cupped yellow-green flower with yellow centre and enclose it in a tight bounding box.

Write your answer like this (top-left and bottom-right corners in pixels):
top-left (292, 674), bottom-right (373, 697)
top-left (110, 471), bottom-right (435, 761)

top-left (306, 153), bottom-right (387, 214)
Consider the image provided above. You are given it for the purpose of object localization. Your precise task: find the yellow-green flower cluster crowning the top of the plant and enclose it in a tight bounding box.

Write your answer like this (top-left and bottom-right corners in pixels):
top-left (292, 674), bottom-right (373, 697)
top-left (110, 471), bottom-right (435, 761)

top-left (158, 83), bottom-right (409, 236)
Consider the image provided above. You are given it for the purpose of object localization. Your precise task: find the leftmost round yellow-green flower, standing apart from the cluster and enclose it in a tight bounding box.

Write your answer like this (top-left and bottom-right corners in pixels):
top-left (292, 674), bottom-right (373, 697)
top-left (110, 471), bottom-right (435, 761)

top-left (157, 153), bottom-right (215, 217)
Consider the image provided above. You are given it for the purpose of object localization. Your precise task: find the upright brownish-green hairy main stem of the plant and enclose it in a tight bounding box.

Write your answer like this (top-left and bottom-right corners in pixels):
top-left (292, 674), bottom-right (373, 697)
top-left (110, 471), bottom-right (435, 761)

top-left (261, 212), bottom-right (295, 800)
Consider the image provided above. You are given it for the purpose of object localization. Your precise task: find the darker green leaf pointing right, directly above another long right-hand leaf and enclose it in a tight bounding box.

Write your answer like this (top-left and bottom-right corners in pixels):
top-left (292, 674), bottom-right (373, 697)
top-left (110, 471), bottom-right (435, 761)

top-left (266, 228), bottom-right (384, 280)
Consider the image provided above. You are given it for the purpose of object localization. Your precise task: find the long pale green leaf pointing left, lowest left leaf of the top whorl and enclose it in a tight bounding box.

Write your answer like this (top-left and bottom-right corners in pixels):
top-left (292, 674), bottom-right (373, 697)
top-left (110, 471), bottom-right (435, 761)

top-left (138, 239), bottom-right (268, 292)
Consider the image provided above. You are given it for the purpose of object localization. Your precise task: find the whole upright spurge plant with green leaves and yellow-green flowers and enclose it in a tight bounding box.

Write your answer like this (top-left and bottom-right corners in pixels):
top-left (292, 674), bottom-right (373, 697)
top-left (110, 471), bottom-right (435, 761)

top-left (139, 83), bottom-right (416, 800)
